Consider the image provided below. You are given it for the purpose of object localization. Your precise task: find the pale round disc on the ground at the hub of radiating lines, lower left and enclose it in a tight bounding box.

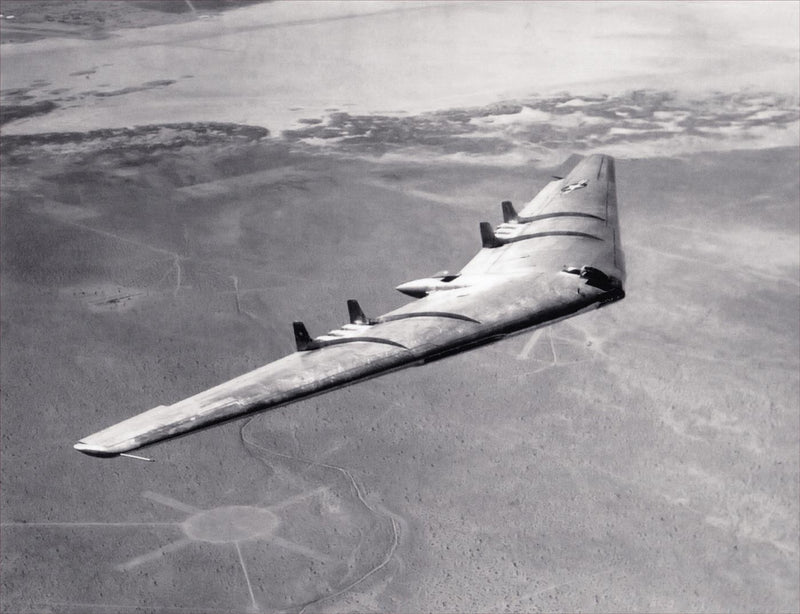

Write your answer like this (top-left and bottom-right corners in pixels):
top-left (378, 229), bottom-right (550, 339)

top-left (183, 505), bottom-right (280, 544)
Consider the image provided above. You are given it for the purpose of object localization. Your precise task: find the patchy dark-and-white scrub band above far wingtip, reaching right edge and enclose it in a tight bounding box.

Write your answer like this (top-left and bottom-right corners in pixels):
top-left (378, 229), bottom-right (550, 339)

top-left (283, 90), bottom-right (798, 155)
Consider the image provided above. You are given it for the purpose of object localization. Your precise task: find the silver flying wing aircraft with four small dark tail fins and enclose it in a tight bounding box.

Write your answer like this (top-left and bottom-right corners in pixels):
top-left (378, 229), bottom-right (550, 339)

top-left (75, 154), bottom-right (625, 457)
